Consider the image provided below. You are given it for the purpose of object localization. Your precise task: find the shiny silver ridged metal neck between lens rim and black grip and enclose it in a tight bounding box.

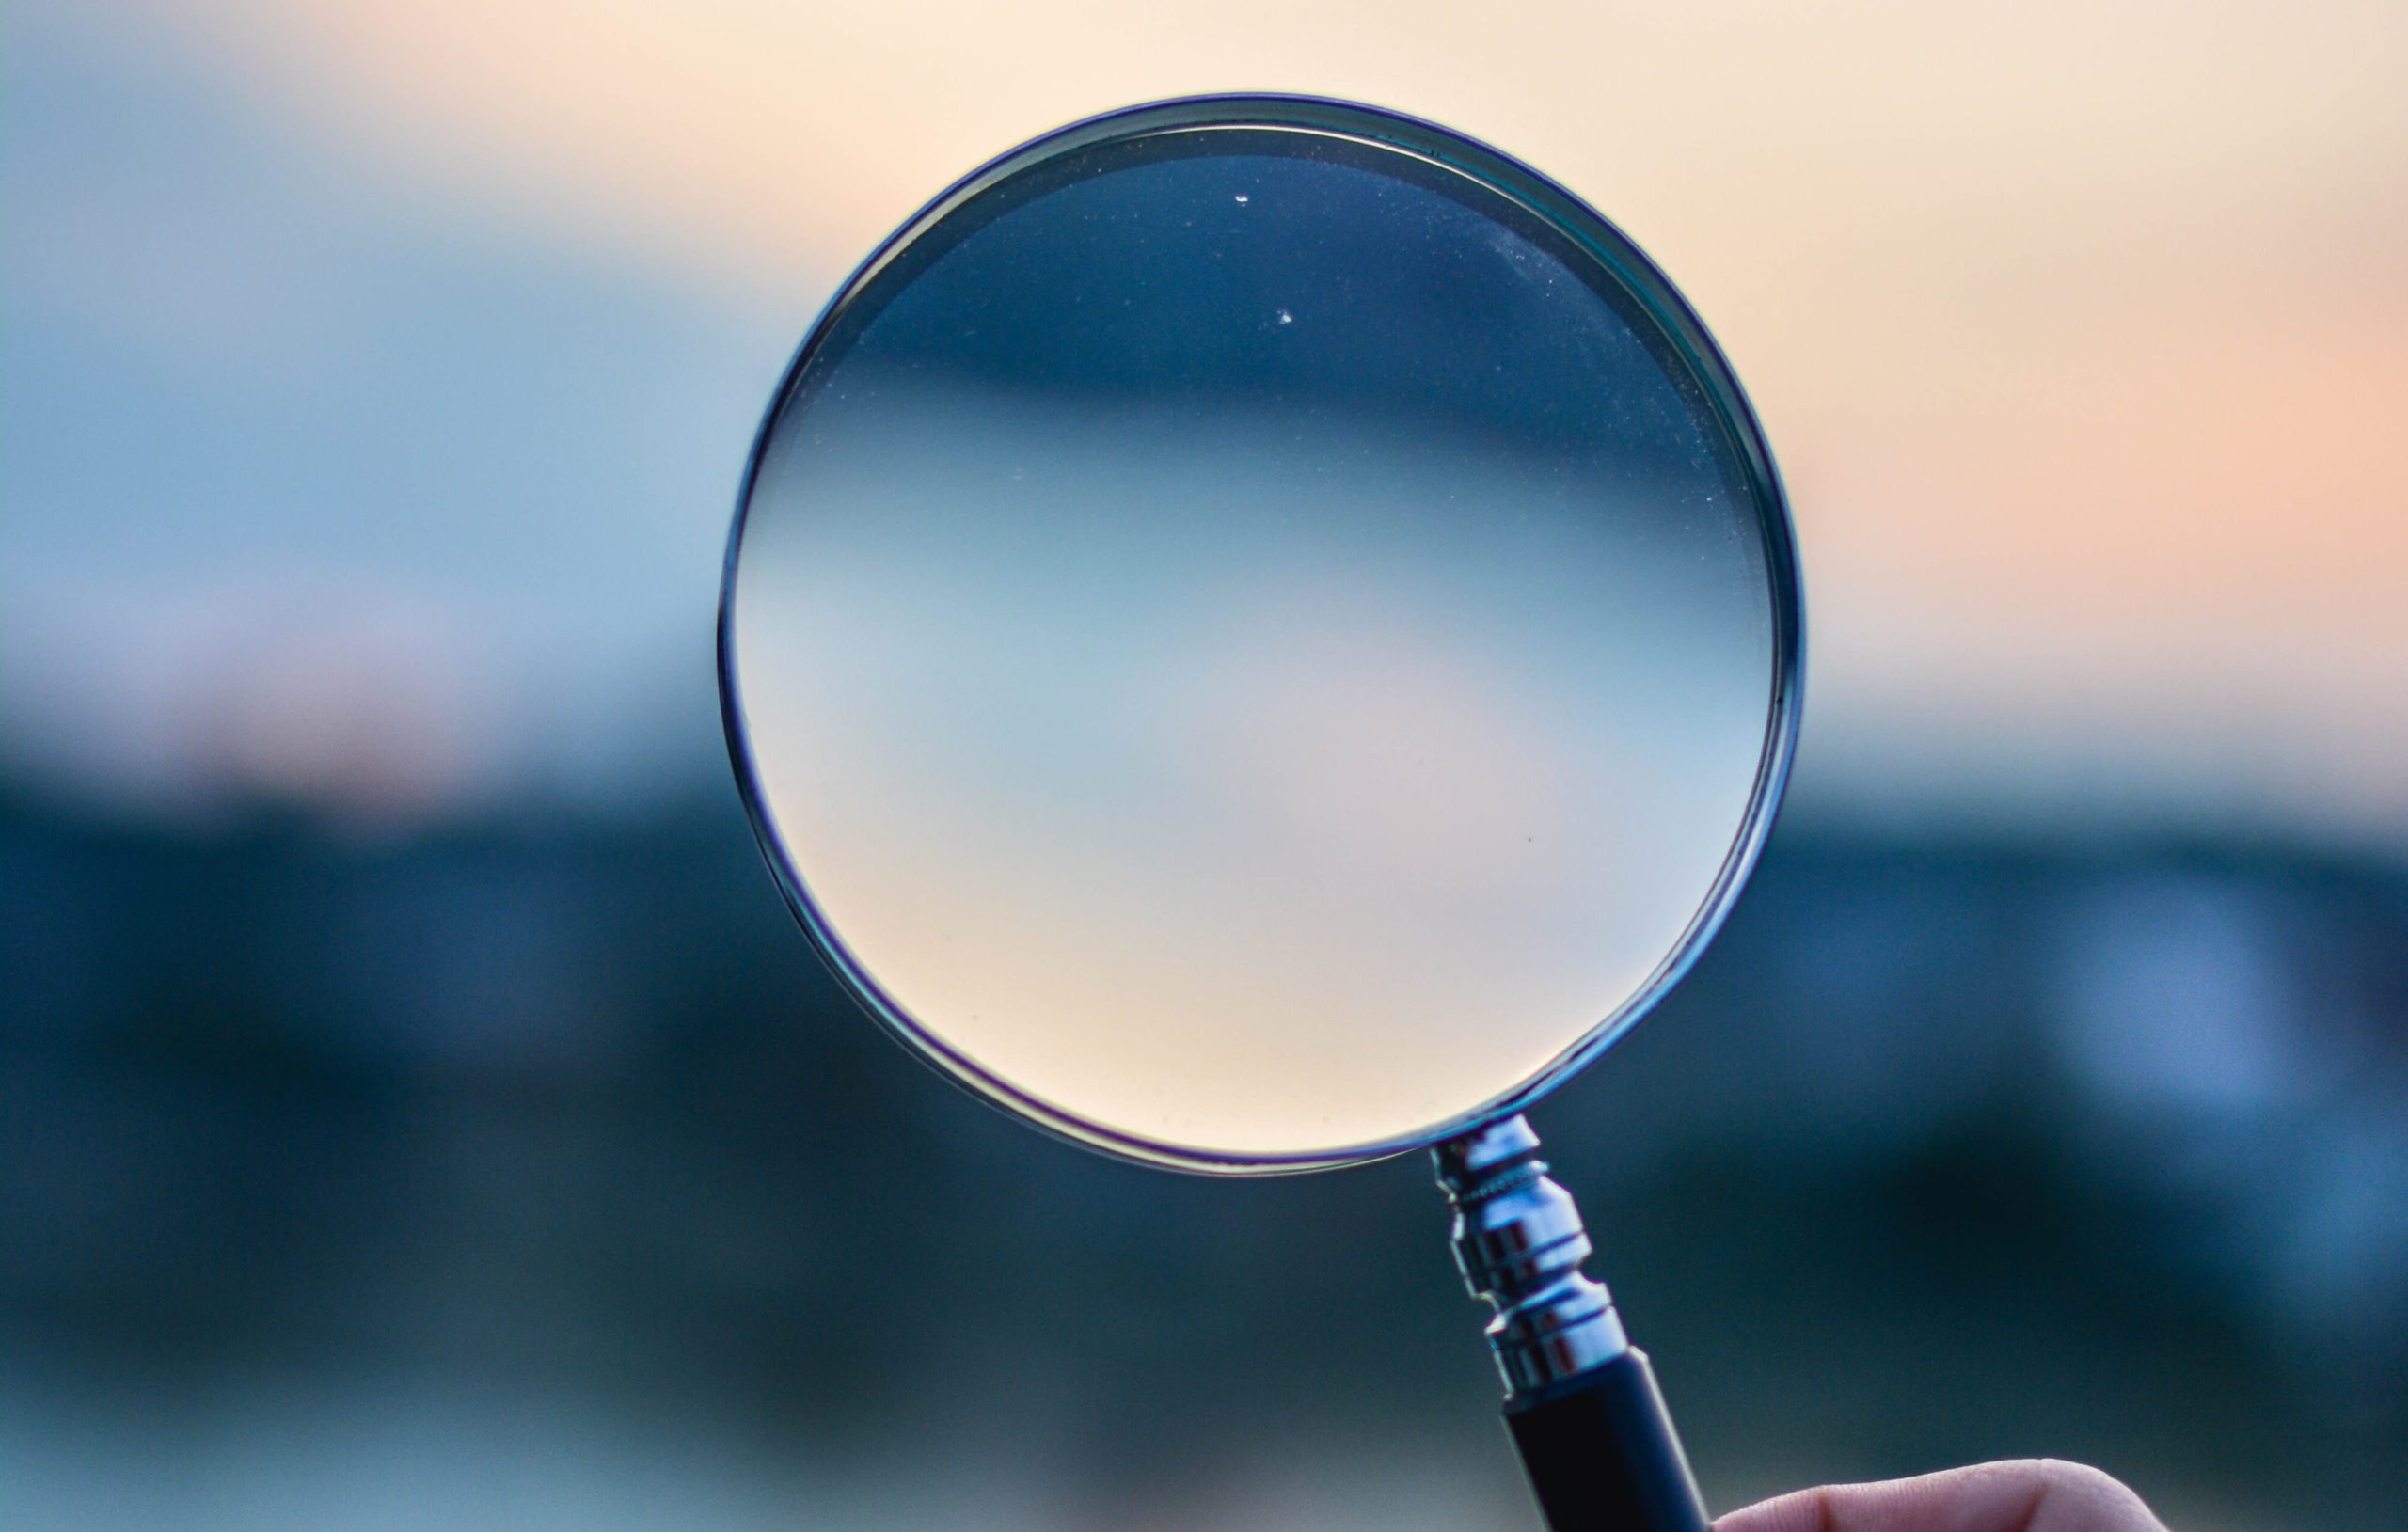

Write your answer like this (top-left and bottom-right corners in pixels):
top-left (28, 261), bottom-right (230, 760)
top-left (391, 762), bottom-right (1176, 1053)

top-left (1431, 1117), bottom-right (1630, 1399)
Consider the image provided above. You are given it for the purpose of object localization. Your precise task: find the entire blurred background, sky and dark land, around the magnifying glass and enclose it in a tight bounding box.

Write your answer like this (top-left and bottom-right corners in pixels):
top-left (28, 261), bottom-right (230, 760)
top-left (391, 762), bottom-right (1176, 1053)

top-left (0, 0), bottom-right (2408, 1532)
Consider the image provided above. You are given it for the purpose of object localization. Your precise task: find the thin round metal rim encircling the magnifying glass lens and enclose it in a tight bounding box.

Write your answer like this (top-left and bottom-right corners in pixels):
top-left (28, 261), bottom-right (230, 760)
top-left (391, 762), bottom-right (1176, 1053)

top-left (718, 94), bottom-right (1806, 1176)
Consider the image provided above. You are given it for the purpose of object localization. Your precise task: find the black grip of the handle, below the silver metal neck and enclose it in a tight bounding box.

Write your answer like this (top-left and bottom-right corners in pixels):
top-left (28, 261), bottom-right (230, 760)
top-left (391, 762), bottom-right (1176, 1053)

top-left (1505, 1349), bottom-right (1707, 1532)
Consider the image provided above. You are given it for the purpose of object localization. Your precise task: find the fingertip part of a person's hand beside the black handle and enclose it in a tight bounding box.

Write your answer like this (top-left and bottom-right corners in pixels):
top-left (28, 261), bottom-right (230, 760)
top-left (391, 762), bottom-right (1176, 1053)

top-left (1715, 1458), bottom-right (2164, 1532)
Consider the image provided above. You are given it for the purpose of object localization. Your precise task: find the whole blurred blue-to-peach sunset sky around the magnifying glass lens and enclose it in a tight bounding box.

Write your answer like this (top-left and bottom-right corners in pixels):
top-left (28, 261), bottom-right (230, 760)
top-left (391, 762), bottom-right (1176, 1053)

top-left (0, 0), bottom-right (2408, 843)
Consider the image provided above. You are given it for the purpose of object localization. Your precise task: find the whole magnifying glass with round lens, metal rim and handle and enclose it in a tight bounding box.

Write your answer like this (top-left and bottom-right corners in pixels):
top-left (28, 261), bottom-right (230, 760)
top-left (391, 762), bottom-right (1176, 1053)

top-left (720, 96), bottom-right (1801, 1532)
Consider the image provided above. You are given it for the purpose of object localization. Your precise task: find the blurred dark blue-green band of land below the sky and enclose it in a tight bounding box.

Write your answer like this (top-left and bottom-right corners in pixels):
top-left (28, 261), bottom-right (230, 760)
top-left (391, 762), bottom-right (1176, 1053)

top-left (0, 799), bottom-right (2408, 1529)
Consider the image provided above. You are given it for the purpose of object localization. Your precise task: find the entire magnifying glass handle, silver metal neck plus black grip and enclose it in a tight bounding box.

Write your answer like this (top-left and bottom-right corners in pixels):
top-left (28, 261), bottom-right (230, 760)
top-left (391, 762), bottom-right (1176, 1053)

top-left (1435, 1117), bottom-right (1707, 1532)
